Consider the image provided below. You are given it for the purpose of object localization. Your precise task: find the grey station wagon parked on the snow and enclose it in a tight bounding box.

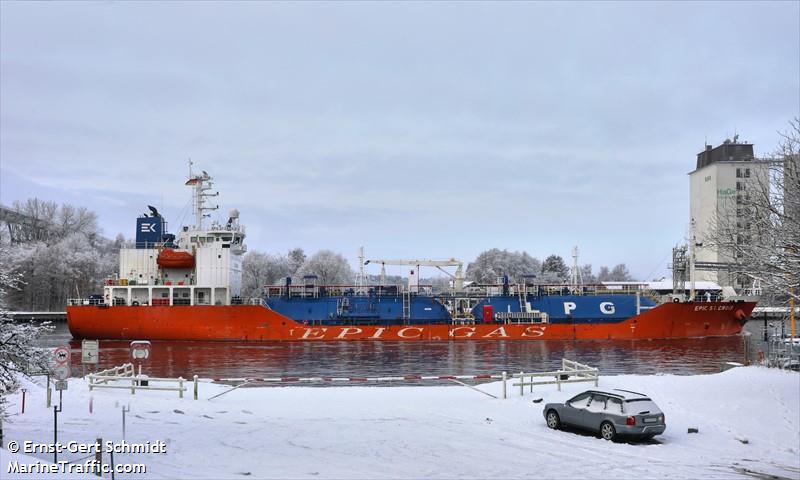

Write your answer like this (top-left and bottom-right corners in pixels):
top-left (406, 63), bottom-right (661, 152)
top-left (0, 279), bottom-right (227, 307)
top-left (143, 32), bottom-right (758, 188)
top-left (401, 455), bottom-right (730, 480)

top-left (543, 389), bottom-right (667, 440)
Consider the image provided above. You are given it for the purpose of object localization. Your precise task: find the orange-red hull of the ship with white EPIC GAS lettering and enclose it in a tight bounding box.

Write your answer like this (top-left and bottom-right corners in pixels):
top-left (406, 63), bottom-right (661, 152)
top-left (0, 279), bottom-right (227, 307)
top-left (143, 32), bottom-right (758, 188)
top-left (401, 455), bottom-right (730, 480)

top-left (67, 302), bottom-right (756, 342)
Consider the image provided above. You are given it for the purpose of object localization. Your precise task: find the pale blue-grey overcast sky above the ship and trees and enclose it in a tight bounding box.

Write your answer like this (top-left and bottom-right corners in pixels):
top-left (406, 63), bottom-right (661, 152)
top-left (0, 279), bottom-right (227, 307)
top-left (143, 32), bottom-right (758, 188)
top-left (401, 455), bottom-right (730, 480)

top-left (0, 1), bottom-right (800, 279)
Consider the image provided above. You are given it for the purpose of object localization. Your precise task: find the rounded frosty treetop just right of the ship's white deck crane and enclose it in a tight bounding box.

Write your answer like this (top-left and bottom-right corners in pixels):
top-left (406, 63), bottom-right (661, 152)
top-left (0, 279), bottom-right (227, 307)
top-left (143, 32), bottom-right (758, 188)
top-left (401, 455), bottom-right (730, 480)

top-left (466, 248), bottom-right (541, 284)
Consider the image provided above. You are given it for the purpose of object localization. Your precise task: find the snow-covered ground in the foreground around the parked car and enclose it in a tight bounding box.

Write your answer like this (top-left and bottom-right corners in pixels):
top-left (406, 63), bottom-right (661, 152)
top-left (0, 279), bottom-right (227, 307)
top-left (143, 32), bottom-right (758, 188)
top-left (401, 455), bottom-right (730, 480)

top-left (0, 367), bottom-right (800, 479)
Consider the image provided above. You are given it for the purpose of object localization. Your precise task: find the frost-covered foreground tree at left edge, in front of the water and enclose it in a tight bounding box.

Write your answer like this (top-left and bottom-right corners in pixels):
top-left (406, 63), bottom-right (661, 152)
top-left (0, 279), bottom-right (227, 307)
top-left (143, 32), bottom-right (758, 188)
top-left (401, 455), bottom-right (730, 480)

top-left (0, 245), bottom-right (50, 422)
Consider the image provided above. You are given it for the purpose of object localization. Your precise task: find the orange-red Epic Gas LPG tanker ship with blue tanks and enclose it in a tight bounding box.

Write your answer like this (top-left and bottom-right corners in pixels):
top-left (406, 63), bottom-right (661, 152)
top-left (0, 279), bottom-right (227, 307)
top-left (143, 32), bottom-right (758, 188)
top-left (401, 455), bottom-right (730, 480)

top-left (66, 169), bottom-right (756, 342)
